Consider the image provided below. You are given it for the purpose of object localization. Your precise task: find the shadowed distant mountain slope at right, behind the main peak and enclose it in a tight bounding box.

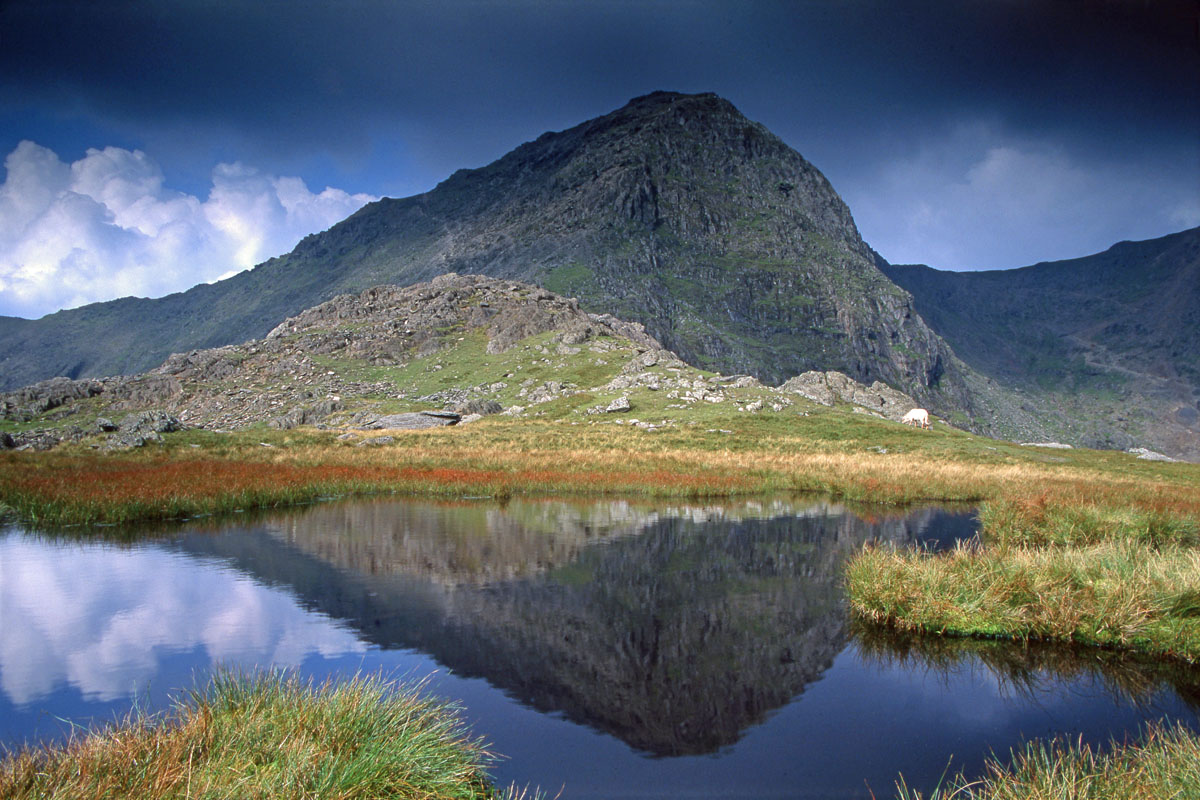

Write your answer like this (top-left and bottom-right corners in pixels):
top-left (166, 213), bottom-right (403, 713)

top-left (880, 228), bottom-right (1200, 461)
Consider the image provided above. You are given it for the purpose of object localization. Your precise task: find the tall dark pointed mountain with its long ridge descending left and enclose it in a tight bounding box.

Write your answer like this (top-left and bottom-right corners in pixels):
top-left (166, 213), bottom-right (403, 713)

top-left (0, 92), bottom-right (971, 413)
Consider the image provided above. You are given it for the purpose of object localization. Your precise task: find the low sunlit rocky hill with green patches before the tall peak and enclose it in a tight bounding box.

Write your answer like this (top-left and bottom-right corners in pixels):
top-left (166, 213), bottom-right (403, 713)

top-left (0, 273), bottom-right (914, 449)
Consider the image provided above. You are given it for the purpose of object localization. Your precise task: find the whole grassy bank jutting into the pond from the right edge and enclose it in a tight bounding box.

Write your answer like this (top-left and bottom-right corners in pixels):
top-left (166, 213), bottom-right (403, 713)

top-left (846, 488), bottom-right (1200, 663)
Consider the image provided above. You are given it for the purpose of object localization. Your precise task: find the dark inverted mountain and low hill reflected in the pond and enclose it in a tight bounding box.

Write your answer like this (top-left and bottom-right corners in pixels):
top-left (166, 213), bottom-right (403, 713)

top-left (185, 503), bottom-right (955, 756)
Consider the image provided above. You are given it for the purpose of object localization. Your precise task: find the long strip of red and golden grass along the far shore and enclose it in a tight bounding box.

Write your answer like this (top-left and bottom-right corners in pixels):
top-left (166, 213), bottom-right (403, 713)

top-left (0, 420), bottom-right (1200, 530)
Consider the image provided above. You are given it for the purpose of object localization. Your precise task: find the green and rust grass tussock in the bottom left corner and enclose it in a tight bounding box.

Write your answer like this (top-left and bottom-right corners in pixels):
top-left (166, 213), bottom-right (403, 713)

top-left (0, 674), bottom-right (525, 800)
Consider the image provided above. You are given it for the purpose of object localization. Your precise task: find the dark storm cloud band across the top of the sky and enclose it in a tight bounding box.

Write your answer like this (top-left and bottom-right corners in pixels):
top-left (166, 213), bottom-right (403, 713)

top-left (0, 0), bottom-right (1200, 169)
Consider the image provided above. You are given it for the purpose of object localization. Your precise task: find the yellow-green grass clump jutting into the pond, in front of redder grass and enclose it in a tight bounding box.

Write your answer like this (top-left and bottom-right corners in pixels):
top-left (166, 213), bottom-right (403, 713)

top-left (846, 541), bottom-right (1200, 661)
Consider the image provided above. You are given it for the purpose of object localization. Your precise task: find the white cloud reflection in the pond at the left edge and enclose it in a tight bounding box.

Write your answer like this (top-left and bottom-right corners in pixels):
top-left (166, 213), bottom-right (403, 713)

top-left (0, 535), bottom-right (366, 705)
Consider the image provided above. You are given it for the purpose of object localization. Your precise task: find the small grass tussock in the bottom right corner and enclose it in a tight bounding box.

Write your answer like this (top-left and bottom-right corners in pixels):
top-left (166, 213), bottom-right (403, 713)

top-left (896, 724), bottom-right (1200, 800)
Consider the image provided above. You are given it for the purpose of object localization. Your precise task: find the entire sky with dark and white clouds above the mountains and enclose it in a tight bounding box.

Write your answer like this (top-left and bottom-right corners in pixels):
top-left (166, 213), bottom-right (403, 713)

top-left (0, 0), bottom-right (1200, 317)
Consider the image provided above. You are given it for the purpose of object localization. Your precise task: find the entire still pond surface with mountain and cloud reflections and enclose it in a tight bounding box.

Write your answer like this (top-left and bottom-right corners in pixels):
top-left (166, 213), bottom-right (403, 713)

top-left (0, 499), bottom-right (1200, 799)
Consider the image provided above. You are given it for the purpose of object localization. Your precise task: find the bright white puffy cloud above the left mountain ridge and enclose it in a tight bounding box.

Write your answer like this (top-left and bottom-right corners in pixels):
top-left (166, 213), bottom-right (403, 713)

top-left (0, 140), bottom-right (377, 317)
